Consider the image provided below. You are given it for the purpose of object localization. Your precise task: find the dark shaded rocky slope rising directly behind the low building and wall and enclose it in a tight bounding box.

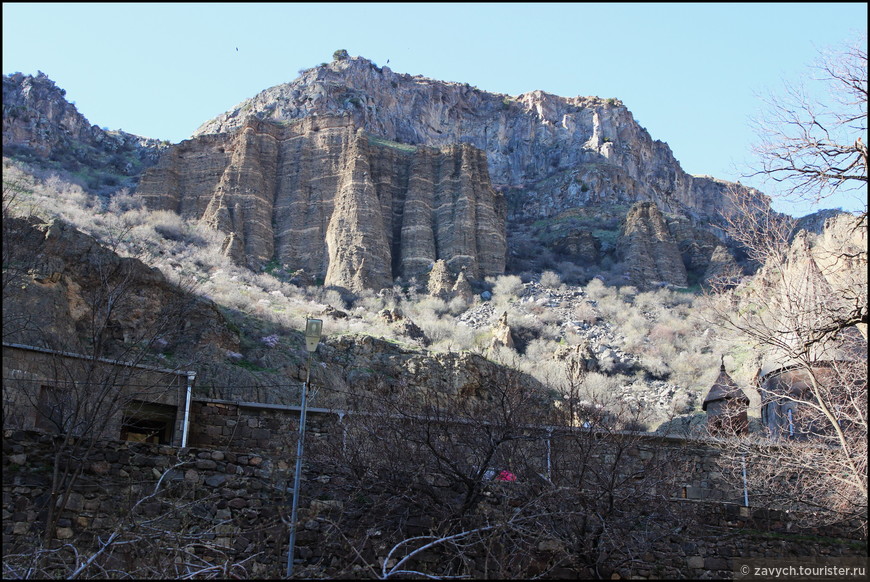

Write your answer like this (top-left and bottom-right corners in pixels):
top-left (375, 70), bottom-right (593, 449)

top-left (3, 212), bottom-right (544, 407)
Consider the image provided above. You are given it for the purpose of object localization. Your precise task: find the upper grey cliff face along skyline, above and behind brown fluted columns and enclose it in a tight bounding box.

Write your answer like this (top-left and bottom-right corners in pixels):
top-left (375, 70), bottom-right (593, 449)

top-left (195, 57), bottom-right (764, 225)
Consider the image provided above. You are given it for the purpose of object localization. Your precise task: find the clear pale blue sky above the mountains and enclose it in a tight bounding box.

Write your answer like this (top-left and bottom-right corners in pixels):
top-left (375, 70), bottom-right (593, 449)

top-left (3, 2), bottom-right (867, 216)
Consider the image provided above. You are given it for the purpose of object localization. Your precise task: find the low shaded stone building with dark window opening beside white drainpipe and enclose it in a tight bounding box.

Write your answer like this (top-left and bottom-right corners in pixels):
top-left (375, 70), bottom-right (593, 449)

top-left (3, 343), bottom-right (196, 446)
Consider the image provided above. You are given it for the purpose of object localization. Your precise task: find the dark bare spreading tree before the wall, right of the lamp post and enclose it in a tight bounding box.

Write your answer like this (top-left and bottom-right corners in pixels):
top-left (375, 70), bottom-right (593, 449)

top-left (306, 360), bottom-right (677, 579)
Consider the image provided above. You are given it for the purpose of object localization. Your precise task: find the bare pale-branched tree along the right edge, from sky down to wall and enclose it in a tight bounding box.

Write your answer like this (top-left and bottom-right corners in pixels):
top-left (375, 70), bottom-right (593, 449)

top-left (710, 36), bottom-right (867, 533)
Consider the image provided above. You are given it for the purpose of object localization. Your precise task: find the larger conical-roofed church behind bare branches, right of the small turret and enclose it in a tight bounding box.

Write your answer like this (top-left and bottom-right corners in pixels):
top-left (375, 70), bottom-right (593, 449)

top-left (755, 237), bottom-right (867, 441)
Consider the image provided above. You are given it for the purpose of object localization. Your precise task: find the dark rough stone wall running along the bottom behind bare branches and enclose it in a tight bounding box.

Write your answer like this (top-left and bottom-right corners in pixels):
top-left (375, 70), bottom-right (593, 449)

top-left (3, 432), bottom-right (867, 578)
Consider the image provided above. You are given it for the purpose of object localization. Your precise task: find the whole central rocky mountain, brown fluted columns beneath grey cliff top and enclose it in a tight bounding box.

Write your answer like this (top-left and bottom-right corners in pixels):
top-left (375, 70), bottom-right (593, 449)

top-left (133, 51), bottom-right (763, 290)
